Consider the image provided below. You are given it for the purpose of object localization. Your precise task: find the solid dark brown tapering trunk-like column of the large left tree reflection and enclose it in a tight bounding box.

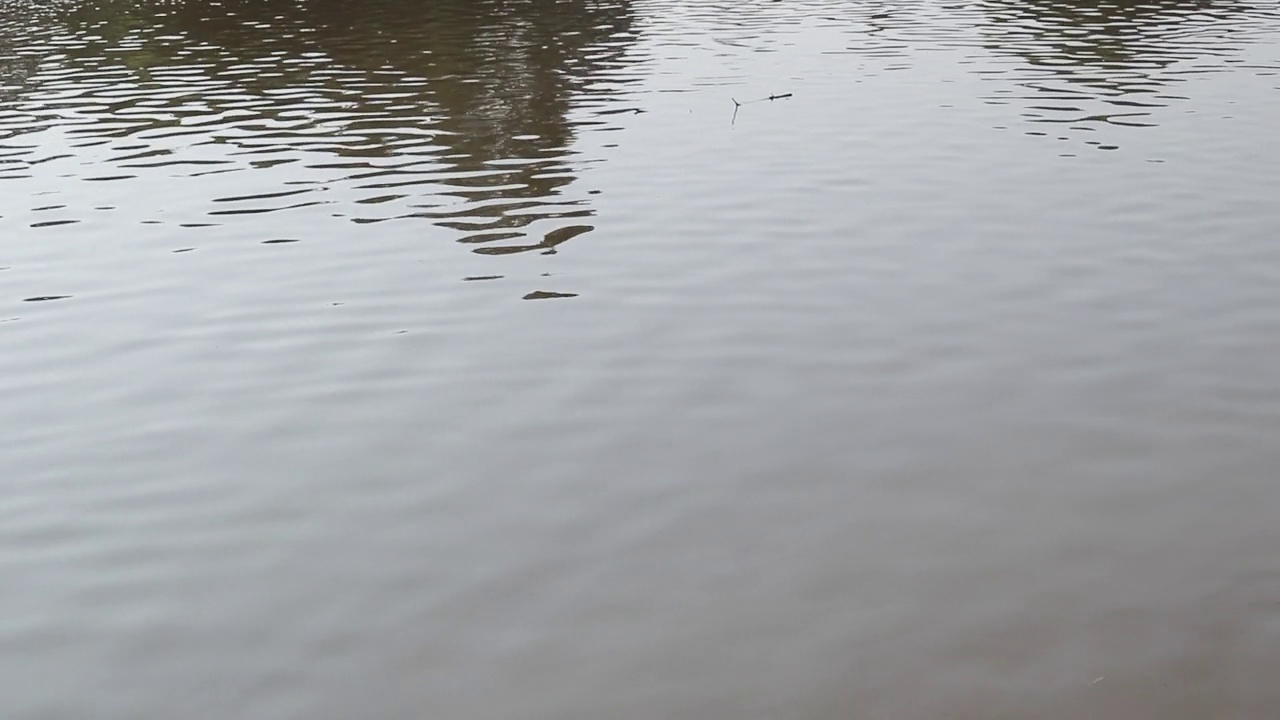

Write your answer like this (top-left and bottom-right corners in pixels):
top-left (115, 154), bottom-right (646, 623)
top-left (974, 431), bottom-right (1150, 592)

top-left (277, 0), bottom-right (630, 255)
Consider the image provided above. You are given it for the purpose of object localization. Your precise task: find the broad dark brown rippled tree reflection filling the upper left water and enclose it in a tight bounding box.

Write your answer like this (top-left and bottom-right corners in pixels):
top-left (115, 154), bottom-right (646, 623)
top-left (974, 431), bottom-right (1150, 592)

top-left (0, 0), bottom-right (635, 269)
